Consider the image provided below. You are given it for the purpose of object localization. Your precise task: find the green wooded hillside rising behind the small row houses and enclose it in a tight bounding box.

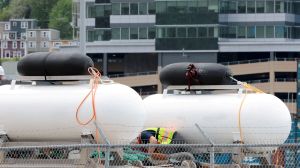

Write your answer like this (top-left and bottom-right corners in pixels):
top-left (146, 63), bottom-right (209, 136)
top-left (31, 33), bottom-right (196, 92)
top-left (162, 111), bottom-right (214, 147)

top-left (0, 0), bottom-right (72, 39)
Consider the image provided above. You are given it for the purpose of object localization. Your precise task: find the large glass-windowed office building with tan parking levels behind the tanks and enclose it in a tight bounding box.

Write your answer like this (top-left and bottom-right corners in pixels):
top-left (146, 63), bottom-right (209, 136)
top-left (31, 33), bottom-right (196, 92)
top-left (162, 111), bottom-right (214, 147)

top-left (73, 0), bottom-right (300, 114)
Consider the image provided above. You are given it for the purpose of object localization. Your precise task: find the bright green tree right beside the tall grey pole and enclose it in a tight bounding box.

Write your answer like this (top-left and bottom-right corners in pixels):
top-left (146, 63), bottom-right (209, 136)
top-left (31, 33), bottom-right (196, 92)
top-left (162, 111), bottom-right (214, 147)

top-left (49, 0), bottom-right (72, 39)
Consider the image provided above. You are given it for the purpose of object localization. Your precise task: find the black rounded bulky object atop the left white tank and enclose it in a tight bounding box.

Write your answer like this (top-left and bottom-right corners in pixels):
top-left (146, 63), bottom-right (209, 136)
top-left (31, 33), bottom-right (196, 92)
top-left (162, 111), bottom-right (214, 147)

top-left (17, 52), bottom-right (94, 76)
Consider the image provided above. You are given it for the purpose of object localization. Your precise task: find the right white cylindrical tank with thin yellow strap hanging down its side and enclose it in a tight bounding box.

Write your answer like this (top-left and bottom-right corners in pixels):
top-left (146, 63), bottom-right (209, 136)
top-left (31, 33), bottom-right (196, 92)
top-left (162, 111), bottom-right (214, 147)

top-left (143, 94), bottom-right (291, 148)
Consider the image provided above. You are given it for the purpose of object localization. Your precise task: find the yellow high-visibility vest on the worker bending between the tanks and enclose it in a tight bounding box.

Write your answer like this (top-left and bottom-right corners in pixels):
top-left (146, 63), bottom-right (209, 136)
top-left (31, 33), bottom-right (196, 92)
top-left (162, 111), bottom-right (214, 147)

top-left (146, 128), bottom-right (175, 144)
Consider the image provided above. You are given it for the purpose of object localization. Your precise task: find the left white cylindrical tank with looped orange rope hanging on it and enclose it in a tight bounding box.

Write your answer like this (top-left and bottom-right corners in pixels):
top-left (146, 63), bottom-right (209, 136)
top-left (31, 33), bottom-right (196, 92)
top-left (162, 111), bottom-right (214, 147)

top-left (0, 83), bottom-right (145, 143)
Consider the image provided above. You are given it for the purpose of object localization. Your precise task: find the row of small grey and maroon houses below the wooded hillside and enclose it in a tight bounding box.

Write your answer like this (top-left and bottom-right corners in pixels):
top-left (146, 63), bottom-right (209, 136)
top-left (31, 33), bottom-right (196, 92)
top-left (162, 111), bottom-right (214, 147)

top-left (0, 19), bottom-right (60, 58)
